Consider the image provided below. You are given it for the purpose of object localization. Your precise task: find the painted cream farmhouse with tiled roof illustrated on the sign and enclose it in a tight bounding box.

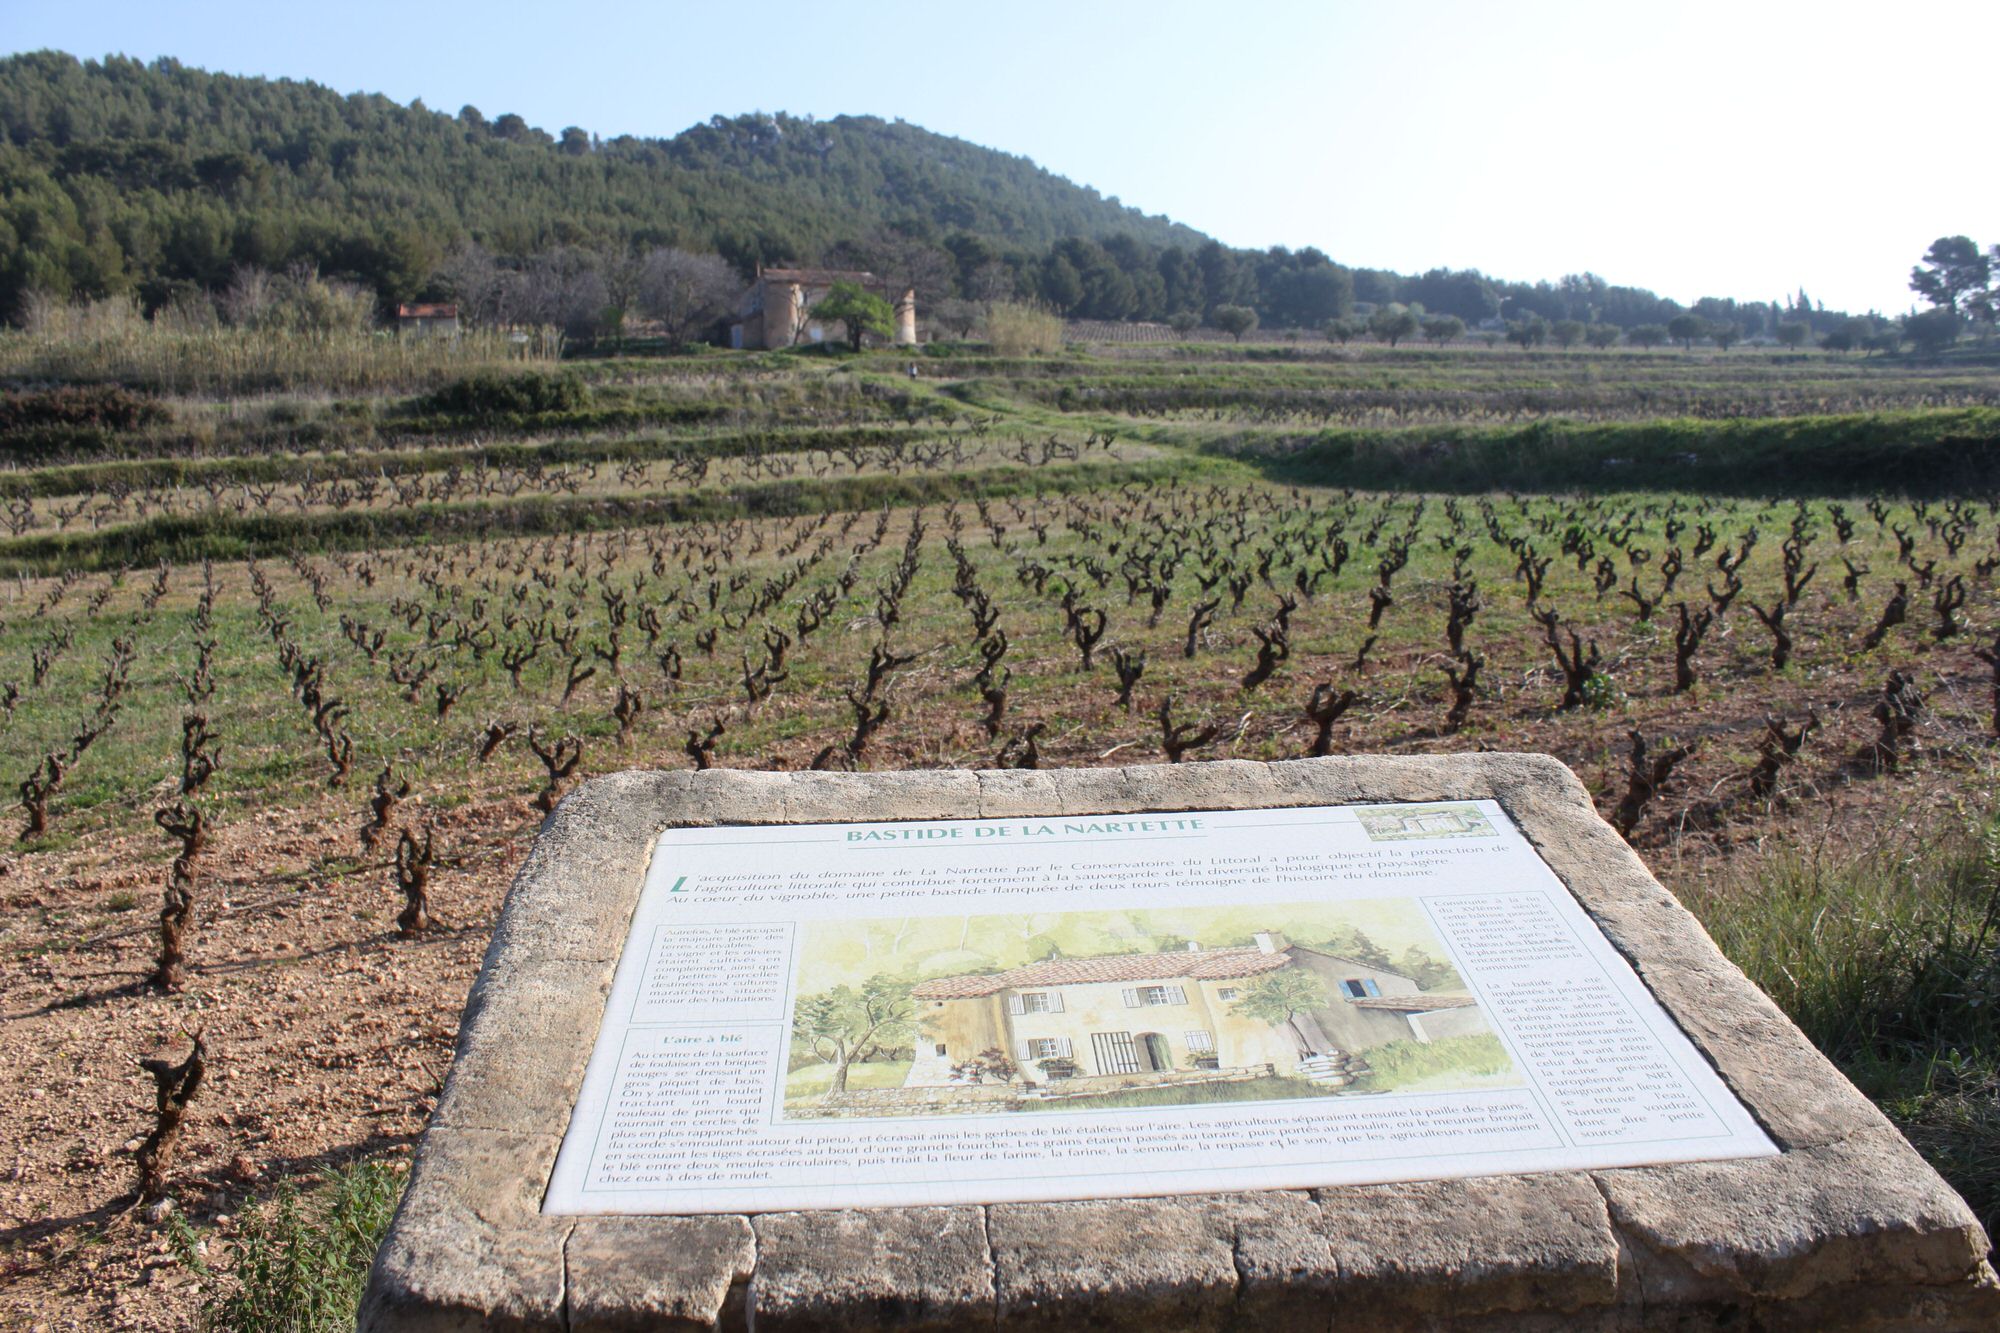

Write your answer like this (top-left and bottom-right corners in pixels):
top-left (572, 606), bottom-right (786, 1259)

top-left (904, 931), bottom-right (1488, 1087)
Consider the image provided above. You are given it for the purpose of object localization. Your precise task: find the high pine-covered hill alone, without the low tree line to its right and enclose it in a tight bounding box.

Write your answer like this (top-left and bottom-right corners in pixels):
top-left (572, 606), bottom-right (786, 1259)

top-left (0, 52), bottom-right (1206, 312)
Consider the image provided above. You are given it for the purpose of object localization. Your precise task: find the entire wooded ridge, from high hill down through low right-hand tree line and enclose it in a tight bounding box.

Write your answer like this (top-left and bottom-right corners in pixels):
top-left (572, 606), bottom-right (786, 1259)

top-left (0, 52), bottom-right (1816, 336)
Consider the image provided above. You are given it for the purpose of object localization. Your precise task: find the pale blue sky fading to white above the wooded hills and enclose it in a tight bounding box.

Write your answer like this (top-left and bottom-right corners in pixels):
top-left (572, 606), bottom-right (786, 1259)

top-left (0, 0), bottom-right (2000, 314)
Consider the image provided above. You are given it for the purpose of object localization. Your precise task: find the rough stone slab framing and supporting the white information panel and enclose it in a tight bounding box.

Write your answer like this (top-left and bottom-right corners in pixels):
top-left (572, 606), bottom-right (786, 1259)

top-left (360, 755), bottom-right (2000, 1333)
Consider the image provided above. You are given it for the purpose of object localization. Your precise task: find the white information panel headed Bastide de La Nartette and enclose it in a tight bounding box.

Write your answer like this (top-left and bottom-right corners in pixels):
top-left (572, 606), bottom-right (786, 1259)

top-left (544, 801), bottom-right (1776, 1213)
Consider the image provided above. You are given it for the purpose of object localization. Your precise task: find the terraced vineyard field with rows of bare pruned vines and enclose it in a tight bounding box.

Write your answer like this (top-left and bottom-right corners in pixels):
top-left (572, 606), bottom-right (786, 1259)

top-left (0, 344), bottom-right (2000, 1329)
